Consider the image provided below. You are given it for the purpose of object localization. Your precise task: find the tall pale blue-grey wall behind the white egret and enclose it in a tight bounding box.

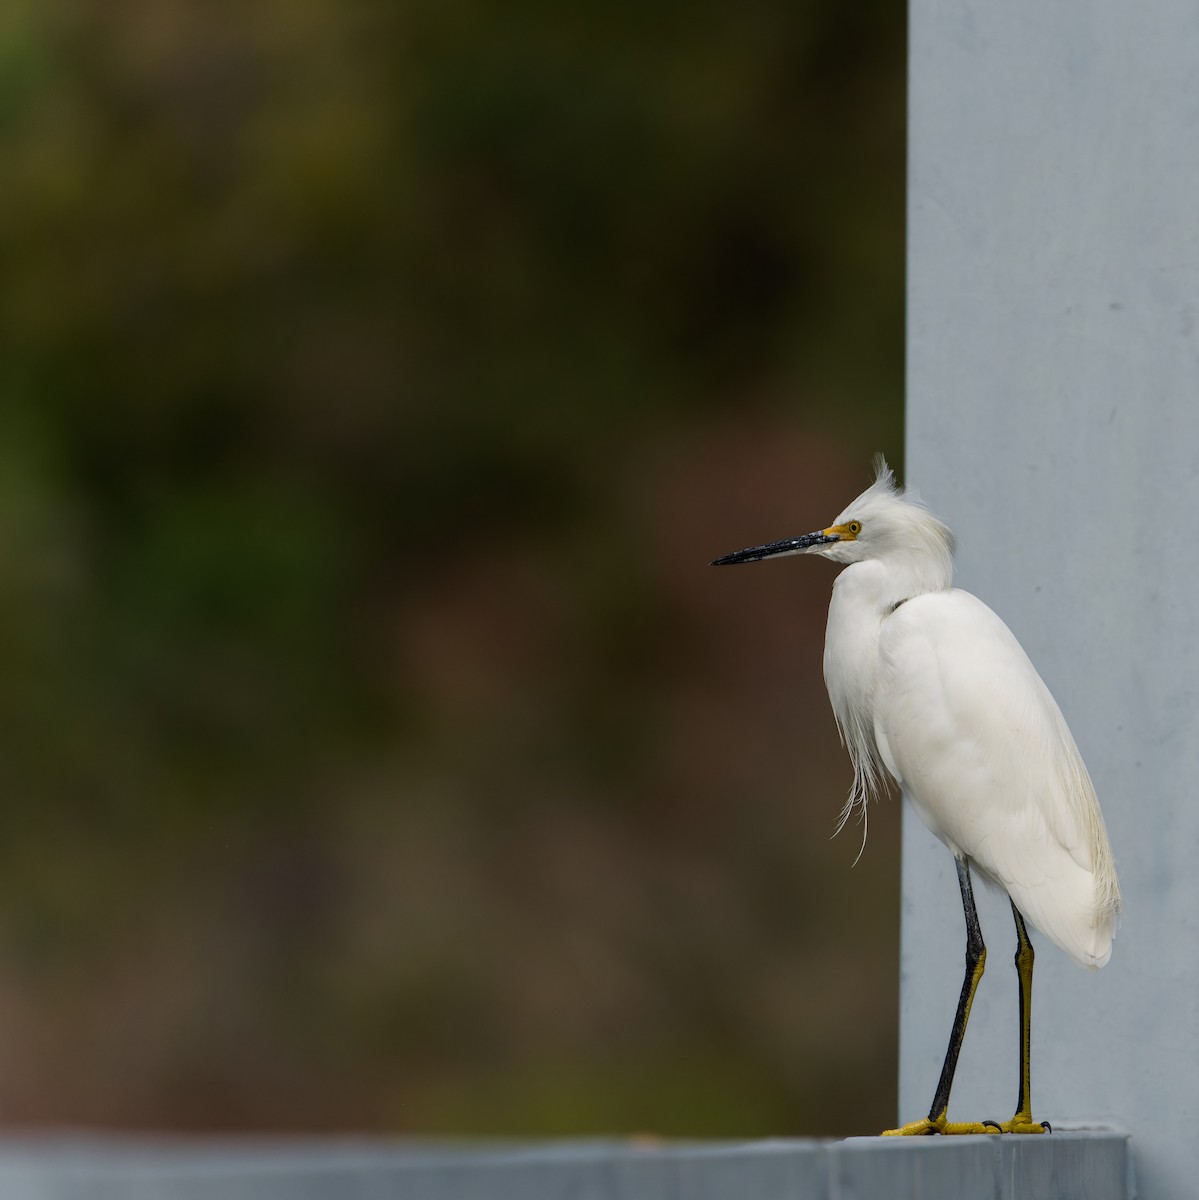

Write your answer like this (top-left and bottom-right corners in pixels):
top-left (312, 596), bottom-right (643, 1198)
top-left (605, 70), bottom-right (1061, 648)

top-left (900, 0), bottom-right (1199, 1200)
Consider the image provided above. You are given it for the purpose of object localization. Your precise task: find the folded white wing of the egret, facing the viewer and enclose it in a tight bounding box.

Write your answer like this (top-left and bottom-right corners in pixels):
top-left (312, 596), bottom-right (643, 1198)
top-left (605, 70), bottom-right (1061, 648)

top-left (875, 590), bottom-right (1119, 966)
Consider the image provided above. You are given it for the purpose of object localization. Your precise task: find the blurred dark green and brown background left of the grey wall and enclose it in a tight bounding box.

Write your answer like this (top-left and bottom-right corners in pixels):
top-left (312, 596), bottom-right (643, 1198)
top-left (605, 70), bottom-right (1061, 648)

top-left (0, 0), bottom-right (904, 1135)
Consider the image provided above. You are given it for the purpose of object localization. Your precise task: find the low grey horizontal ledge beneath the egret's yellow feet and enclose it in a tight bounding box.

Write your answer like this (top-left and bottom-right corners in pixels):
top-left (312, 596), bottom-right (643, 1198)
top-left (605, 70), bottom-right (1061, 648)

top-left (0, 1132), bottom-right (1133, 1200)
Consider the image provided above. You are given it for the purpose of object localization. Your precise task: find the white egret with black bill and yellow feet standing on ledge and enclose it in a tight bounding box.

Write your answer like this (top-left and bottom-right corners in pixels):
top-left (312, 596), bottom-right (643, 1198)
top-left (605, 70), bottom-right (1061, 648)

top-left (712, 455), bottom-right (1121, 1136)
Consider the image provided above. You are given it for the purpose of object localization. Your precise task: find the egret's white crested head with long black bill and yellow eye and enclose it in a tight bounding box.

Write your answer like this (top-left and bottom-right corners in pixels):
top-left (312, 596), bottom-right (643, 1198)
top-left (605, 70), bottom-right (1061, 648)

top-left (712, 455), bottom-right (953, 587)
